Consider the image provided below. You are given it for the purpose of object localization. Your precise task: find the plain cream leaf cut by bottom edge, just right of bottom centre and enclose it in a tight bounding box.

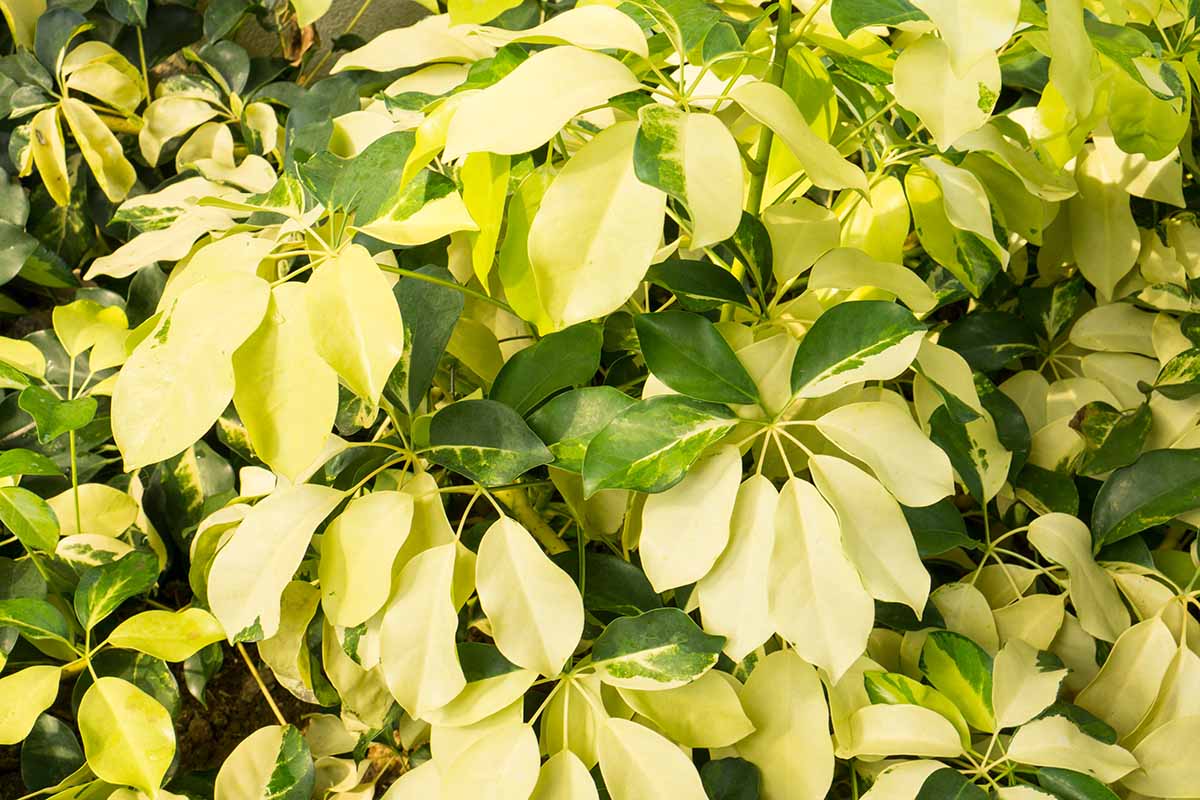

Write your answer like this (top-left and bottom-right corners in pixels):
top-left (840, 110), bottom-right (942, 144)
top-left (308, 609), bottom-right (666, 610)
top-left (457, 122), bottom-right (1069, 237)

top-left (600, 718), bottom-right (708, 800)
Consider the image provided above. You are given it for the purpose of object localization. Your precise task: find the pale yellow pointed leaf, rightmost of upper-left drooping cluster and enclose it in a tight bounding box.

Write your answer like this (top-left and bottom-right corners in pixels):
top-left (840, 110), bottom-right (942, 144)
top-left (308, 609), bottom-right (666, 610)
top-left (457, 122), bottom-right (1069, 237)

top-left (307, 245), bottom-right (404, 403)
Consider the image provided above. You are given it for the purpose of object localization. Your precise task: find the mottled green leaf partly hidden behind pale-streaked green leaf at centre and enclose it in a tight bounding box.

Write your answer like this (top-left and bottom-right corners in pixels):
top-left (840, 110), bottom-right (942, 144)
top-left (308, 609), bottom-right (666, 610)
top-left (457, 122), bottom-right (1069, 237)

top-left (527, 386), bottom-right (637, 473)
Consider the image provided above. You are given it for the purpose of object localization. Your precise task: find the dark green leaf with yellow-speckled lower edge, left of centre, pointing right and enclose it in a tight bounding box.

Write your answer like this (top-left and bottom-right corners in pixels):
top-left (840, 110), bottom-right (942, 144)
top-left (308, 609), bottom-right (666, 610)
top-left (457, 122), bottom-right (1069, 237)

top-left (424, 399), bottom-right (554, 486)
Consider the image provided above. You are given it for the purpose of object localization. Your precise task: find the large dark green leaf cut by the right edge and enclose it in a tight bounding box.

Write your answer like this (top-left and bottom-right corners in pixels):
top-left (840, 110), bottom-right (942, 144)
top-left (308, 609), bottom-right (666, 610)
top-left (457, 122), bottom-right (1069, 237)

top-left (1092, 450), bottom-right (1200, 549)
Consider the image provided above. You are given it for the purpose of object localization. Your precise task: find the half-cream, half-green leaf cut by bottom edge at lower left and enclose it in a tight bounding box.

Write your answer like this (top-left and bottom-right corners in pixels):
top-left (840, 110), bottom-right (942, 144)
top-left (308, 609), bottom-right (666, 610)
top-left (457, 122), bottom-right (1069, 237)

top-left (214, 724), bottom-right (316, 800)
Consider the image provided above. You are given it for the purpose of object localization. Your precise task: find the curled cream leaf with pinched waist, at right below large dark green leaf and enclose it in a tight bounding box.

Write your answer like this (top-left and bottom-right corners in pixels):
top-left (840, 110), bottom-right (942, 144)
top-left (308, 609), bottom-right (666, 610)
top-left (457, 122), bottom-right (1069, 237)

top-left (1028, 513), bottom-right (1129, 642)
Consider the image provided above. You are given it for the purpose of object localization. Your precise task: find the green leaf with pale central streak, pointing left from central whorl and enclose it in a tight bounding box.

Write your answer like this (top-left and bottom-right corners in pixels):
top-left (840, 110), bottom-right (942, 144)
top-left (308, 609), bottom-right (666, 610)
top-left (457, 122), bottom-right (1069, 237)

top-left (583, 395), bottom-right (737, 497)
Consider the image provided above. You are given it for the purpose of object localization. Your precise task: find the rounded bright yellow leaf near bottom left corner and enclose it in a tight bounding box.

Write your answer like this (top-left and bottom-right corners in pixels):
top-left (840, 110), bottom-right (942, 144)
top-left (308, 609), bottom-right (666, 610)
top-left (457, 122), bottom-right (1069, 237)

top-left (78, 678), bottom-right (175, 796)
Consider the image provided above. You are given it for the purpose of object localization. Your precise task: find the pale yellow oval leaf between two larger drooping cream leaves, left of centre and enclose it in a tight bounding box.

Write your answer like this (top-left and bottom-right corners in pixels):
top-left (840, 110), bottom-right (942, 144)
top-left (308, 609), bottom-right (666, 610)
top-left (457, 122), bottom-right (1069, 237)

top-left (318, 492), bottom-right (414, 627)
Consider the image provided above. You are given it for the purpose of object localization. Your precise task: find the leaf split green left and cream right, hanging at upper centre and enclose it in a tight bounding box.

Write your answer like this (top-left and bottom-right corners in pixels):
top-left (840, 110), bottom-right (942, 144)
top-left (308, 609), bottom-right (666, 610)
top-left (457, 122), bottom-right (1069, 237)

top-left (634, 103), bottom-right (743, 249)
